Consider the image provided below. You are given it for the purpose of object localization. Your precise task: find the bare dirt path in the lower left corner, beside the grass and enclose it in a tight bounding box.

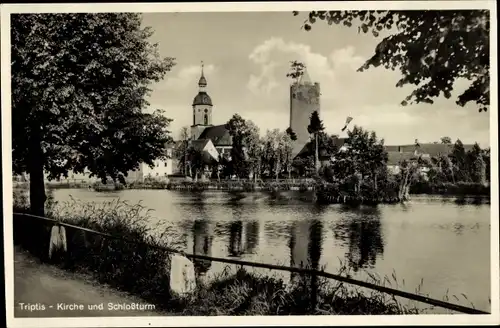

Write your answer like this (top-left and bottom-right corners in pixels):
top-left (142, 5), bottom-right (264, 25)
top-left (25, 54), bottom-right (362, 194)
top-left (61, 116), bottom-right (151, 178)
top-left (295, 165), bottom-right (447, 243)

top-left (14, 248), bottom-right (172, 318)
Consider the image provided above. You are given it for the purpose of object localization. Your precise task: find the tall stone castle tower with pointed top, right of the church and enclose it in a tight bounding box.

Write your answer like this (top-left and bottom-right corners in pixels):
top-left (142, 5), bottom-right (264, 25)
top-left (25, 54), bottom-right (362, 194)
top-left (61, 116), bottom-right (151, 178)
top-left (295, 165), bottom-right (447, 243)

top-left (290, 69), bottom-right (320, 156)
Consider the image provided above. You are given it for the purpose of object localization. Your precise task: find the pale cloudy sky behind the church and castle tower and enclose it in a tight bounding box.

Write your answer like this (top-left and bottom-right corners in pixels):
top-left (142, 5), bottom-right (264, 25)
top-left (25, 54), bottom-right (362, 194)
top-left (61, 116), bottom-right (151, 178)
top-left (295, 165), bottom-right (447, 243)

top-left (143, 11), bottom-right (490, 147)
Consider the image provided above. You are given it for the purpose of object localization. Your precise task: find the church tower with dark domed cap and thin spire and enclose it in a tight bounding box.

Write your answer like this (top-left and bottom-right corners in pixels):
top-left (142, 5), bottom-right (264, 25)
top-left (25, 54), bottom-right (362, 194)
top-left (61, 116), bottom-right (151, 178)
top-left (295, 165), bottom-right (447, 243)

top-left (191, 62), bottom-right (213, 140)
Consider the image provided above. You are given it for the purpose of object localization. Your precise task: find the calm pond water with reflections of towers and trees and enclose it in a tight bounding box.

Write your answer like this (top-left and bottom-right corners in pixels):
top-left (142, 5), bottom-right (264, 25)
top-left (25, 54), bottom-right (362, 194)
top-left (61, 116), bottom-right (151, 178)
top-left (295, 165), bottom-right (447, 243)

top-left (54, 189), bottom-right (490, 311)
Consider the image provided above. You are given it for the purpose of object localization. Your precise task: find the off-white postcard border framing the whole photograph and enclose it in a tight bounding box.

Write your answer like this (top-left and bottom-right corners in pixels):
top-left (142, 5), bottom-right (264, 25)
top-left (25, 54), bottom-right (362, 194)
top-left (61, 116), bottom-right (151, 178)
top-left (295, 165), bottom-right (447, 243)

top-left (1, 0), bottom-right (500, 327)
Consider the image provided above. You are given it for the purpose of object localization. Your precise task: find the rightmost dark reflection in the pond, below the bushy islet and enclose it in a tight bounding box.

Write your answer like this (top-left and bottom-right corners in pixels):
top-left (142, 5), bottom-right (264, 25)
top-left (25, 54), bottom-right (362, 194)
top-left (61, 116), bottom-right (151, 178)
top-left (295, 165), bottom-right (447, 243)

top-left (333, 207), bottom-right (384, 272)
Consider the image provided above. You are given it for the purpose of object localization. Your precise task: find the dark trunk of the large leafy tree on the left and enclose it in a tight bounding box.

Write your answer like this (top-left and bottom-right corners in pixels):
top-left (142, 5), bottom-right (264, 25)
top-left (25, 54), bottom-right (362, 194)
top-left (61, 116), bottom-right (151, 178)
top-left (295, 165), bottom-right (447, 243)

top-left (28, 123), bottom-right (46, 216)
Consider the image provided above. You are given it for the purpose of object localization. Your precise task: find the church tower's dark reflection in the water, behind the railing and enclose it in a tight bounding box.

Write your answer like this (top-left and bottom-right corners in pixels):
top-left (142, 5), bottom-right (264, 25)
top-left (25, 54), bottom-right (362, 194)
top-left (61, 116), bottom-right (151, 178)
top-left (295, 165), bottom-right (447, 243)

top-left (193, 220), bottom-right (213, 276)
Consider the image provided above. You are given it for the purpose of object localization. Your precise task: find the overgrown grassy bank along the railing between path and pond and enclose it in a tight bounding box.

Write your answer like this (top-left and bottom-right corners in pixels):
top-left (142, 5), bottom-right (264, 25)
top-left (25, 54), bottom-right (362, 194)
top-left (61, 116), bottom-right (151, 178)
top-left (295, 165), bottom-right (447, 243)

top-left (14, 192), bottom-right (440, 315)
